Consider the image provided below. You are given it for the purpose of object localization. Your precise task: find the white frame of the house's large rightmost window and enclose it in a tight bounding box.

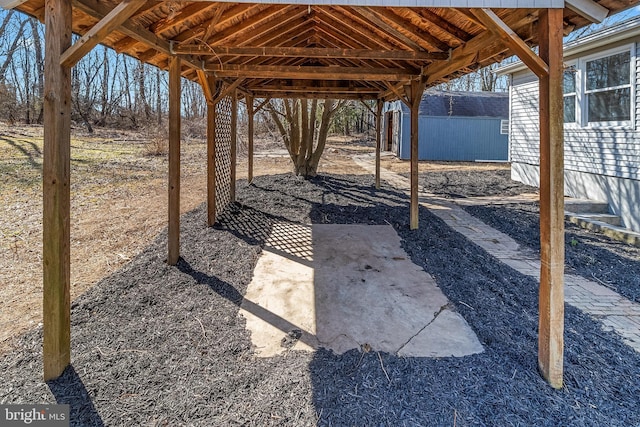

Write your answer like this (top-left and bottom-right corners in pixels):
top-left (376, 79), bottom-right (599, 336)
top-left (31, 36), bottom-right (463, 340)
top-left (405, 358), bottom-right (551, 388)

top-left (576, 43), bottom-right (636, 129)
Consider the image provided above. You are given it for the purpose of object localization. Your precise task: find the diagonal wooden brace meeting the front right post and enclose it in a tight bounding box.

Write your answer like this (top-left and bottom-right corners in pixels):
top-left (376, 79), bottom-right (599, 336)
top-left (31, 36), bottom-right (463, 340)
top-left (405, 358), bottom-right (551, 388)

top-left (471, 9), bottom-right (549, 77)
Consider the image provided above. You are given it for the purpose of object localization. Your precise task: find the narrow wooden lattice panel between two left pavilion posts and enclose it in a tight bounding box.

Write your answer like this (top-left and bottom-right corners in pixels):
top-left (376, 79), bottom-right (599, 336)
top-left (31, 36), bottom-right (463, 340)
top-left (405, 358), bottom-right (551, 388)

top-left (215, 96), bottom-right (232, 216)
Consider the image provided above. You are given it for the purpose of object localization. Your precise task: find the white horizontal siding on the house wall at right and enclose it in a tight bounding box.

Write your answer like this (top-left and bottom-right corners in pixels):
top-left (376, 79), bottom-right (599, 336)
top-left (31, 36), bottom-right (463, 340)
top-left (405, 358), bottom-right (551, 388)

top-left (509, 44), bottom-right (640, 231)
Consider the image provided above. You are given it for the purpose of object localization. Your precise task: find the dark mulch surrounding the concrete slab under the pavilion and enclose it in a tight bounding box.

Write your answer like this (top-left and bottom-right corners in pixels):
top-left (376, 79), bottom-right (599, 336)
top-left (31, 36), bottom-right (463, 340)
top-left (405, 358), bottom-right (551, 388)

top-left (0, 176), bottom-right (640, 426)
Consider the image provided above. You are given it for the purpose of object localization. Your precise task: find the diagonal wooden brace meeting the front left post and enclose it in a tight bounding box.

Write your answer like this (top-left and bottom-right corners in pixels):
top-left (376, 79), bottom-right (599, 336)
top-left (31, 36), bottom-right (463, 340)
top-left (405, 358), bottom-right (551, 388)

top-left (60, 0), bottom-right (147, 67)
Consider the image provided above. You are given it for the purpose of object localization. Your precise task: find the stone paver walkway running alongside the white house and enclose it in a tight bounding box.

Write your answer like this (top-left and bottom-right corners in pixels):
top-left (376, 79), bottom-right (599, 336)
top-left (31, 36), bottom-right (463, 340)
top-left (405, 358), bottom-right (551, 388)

top-left (354, 156), bottom-right (640, 352)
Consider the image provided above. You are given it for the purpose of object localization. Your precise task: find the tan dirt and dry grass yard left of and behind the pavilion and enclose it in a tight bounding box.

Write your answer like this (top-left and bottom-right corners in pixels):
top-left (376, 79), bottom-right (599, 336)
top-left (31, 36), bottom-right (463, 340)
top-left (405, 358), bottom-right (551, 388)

top-left (0, 124), bottom-right (374, 353)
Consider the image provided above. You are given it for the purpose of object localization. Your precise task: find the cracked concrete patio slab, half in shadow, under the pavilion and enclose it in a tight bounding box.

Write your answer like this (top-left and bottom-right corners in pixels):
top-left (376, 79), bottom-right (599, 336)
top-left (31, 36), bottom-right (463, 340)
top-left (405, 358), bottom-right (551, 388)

top-left (240, 224), bottom-right (483, 357)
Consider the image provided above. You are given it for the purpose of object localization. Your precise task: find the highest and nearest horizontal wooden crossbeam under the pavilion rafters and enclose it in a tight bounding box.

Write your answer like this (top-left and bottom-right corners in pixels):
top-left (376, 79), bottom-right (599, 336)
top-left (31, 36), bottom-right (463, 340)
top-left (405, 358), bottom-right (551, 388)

top-left (174, 44), bottom-right (449, 61)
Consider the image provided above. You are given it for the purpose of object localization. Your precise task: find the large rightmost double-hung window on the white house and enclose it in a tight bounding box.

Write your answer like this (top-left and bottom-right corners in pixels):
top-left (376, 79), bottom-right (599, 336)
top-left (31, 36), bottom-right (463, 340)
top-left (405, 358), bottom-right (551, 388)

top-left (584, 51), bottom-right (631, 123)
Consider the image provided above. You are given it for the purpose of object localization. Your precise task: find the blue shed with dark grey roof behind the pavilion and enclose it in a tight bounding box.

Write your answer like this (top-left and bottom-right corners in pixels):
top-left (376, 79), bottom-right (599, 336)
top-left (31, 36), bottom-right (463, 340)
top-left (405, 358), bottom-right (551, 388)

top-left (383, 90), bottom-right (509, 161)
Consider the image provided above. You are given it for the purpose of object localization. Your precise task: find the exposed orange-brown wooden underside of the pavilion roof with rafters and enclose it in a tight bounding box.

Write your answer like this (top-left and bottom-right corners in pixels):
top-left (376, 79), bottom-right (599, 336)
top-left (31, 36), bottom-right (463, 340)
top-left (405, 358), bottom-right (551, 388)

top-left (11, 0), bottom-right (638, 100)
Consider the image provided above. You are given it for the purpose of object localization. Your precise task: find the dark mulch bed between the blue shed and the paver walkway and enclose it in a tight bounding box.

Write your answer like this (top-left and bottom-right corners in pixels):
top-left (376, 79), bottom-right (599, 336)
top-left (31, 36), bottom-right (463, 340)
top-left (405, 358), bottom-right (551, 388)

top-left (402, 169), bottom-right (538, 198)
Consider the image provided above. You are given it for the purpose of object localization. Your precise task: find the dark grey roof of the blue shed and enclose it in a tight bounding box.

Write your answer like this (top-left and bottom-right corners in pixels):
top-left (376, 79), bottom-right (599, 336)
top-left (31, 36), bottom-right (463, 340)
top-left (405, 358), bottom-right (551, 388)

top-left (419, 90), bottom-right (509, 119)
